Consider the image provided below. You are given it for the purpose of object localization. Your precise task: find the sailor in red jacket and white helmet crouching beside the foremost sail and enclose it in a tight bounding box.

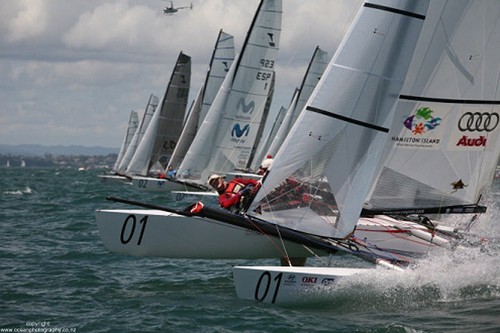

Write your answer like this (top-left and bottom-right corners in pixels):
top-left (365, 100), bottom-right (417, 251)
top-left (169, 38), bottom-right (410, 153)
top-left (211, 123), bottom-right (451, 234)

top-left (208, 174), bottom-right (261, 210)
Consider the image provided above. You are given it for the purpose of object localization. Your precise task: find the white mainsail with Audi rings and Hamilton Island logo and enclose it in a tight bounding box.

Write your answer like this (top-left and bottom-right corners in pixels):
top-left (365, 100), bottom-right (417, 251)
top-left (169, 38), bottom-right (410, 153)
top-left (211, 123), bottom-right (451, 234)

top-left (368, 0), bottom-right (500, 213)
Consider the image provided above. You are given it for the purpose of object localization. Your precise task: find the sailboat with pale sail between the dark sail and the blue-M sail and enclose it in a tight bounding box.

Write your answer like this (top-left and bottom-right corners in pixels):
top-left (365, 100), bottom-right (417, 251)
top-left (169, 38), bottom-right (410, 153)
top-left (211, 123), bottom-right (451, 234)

top-left (132, 30), bottom-right (235, 191)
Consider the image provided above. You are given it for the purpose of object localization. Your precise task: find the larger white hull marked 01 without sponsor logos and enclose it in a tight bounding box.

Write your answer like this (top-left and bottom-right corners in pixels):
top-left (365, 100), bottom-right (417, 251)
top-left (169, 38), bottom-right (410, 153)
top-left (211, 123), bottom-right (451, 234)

top-left (96, 209), bottom-right (311, 259)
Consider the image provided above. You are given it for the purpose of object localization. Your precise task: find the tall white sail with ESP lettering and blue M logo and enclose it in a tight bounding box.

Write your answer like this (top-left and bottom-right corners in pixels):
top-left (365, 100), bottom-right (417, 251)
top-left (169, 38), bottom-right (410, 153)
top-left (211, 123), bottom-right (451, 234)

top-left (177, 0), bottom-right (282, 183)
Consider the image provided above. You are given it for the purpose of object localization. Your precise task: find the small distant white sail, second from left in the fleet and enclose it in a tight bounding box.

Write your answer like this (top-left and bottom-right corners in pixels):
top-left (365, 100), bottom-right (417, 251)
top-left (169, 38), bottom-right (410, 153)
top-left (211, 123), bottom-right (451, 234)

top-left (115, 94), bottom-right (159, 173)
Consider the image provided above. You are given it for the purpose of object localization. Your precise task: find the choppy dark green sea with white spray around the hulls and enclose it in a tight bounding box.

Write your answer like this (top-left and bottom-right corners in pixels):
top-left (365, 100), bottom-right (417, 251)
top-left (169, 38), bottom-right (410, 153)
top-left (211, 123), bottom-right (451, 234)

top-left (0, 168), bottom-right (500, 333)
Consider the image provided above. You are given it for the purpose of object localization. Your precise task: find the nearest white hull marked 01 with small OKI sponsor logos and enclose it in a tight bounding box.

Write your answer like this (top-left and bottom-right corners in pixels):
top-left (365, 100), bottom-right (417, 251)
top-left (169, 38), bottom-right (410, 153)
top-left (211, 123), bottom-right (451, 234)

top-left (233, 266), bottom-right (373, 305)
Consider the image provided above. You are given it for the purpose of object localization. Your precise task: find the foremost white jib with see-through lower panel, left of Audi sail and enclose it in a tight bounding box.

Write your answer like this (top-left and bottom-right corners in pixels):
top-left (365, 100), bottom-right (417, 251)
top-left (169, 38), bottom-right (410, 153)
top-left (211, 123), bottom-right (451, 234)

top-left (251, 0), bottom-right (428, 238)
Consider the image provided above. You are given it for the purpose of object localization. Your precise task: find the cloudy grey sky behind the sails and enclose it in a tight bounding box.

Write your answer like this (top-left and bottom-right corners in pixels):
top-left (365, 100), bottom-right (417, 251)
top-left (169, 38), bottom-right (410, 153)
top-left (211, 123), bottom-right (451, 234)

top-left (0, 0), bottom-right (361, 148)
